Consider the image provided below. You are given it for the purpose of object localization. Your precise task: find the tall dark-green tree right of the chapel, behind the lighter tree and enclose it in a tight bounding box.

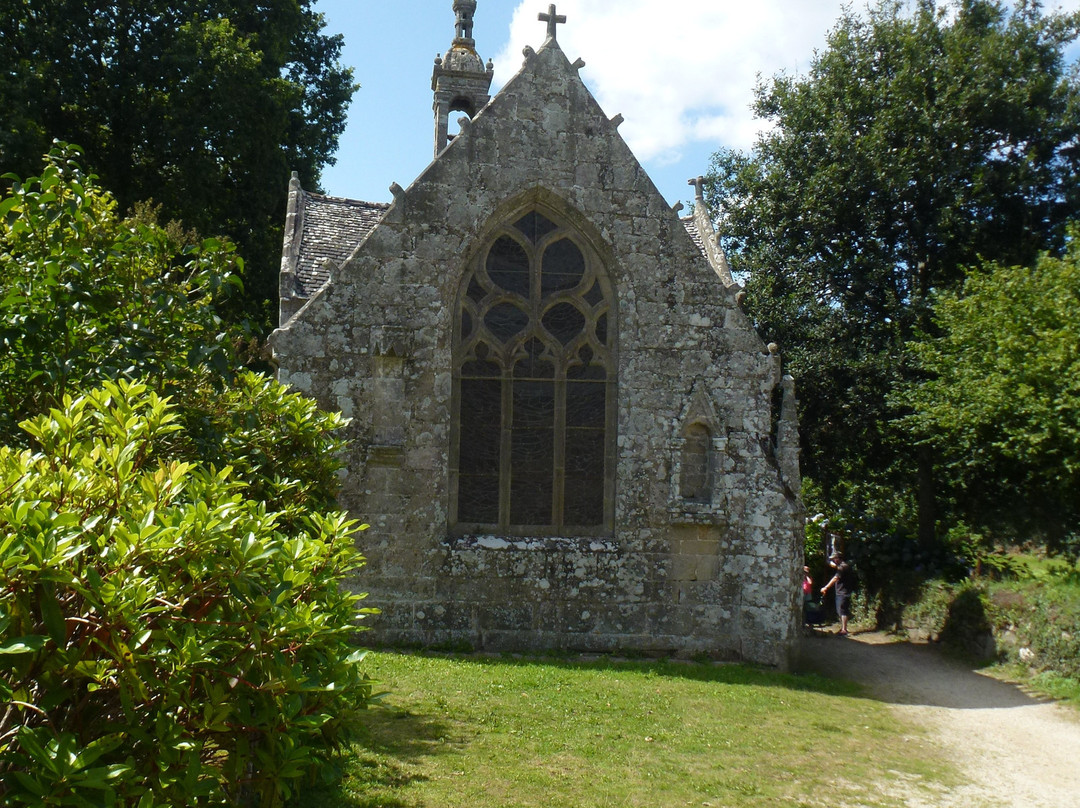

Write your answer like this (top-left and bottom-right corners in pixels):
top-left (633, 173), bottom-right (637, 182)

top-left (706, 0), bottom-right (1080, 541)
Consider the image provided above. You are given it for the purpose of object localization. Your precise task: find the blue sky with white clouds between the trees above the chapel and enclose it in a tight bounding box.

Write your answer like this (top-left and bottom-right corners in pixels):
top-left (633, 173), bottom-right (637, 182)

top-left (315, 0), bottom-right (1080, 211)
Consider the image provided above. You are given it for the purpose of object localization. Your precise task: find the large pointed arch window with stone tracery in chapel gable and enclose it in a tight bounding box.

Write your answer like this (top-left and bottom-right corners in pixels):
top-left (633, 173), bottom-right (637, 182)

top-left (450, 211), bottom-right (616, 535)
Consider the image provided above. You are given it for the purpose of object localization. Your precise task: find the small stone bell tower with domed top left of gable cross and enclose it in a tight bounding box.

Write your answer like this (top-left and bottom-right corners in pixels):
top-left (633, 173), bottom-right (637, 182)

top-left (431, 0), bottom-right (495, 156)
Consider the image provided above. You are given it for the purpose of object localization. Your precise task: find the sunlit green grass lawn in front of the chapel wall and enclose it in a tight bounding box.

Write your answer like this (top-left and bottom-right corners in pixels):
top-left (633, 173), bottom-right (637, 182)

top-left (294, 652), bottom-right (955, 808)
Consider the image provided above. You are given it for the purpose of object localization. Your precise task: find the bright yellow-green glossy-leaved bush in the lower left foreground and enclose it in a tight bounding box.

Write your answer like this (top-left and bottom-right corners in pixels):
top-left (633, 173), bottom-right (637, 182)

top-left (0, 381), bottom-right (372, 808)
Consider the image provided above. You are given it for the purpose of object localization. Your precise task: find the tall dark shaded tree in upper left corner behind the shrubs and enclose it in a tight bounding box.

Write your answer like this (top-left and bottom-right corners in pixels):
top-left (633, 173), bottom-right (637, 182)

top-left (0, 0), bottom-right (355, 320)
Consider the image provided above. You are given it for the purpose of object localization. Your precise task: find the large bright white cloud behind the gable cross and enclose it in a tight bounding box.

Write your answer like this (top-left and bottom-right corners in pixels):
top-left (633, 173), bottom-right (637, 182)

top-left (495, 0), bottom-right (1080, 165)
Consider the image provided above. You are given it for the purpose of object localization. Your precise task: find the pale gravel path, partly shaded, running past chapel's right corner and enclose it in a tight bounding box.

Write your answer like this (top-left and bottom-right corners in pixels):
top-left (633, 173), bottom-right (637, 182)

top-left (802, 632), bottom-right (1080, 808)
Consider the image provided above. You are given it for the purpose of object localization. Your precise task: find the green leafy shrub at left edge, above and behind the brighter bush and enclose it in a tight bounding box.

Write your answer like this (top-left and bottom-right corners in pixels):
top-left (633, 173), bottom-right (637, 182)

top-left (0, 147), bottom-right (242, 442)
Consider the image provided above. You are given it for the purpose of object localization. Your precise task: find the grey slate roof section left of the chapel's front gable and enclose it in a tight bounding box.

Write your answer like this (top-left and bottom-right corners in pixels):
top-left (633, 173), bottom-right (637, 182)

top-left (296, 191), bottom-right (390, 298)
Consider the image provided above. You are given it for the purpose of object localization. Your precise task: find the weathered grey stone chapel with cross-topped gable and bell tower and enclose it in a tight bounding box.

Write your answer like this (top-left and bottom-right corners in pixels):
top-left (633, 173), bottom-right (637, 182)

top-left (271, 0), bottom-right (804, 668)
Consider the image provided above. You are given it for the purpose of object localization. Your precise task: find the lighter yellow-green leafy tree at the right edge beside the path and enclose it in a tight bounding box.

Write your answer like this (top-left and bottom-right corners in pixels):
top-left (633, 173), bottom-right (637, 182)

top-left (903, 238), bottom-right (1080, 544)
